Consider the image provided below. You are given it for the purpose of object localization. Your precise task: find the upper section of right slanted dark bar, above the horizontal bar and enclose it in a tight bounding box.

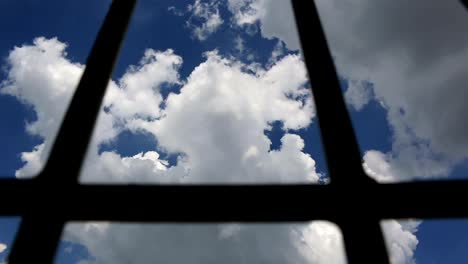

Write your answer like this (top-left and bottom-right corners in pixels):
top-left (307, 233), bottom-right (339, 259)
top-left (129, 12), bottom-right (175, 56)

top-left (292, 0), bottom-right (373, 187)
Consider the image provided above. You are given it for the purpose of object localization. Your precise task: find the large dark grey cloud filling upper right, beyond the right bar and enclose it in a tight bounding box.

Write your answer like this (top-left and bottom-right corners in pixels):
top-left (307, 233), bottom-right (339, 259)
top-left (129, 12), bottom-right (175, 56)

top-left (318, 0), bottom-right (468, 180)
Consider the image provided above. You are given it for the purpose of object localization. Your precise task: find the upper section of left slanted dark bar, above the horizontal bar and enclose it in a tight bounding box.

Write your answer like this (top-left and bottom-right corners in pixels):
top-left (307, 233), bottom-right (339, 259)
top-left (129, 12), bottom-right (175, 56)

top-left (37, 0), bottom-right (136, 184)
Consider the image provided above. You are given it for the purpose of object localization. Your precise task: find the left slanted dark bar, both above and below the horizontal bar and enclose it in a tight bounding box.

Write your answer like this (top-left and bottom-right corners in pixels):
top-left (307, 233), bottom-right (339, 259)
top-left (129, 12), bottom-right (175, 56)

top-left (9, 0), bottom-right (136, 264)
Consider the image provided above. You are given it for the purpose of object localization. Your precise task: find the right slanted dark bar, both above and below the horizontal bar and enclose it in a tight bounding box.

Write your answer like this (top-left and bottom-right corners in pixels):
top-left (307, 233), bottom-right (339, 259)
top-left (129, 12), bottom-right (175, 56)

top-left (292, 0), bottom-right (389, 264)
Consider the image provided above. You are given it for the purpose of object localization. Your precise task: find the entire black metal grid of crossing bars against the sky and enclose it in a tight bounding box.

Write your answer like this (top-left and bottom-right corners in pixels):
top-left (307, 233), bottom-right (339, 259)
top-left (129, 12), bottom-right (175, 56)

top-left (4, 0), bottom-right (468, 264)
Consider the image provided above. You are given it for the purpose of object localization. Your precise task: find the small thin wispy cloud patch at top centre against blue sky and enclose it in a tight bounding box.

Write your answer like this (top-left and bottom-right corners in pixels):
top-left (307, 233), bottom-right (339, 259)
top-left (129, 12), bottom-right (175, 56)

top-left (187, 0), bottom-right (224, 41)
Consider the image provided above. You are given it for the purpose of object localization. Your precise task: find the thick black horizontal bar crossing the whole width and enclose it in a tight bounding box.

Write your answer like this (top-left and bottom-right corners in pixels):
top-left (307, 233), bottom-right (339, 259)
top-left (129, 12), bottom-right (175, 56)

top-left (5, 181), bottom-right (468, 222)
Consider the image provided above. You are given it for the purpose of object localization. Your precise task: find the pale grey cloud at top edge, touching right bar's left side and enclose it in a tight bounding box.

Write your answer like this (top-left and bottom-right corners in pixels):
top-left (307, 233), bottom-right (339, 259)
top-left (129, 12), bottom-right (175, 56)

top-left (228, 0), bottom-right (300, 50)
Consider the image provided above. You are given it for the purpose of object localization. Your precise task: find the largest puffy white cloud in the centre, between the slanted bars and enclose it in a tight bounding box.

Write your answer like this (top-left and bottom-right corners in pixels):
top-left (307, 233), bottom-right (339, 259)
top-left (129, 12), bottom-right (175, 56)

top-left (117, 52), bottom-right (318, 182)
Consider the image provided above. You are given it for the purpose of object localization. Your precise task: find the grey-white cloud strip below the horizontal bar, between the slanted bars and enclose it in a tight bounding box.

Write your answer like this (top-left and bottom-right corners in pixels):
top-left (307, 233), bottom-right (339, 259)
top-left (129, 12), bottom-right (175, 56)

top-left (64, 222), bottom-right (346, 264)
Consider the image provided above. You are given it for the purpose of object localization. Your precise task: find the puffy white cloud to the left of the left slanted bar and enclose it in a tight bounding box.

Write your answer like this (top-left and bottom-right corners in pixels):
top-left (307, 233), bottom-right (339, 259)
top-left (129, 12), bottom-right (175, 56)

top-left (0, 38), bottom-right (84, 177)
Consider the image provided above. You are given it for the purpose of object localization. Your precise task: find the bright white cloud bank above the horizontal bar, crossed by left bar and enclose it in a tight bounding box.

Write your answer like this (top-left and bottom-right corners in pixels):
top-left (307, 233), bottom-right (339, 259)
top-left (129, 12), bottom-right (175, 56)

top-left (1, 38), bottom-right (318, 182)
